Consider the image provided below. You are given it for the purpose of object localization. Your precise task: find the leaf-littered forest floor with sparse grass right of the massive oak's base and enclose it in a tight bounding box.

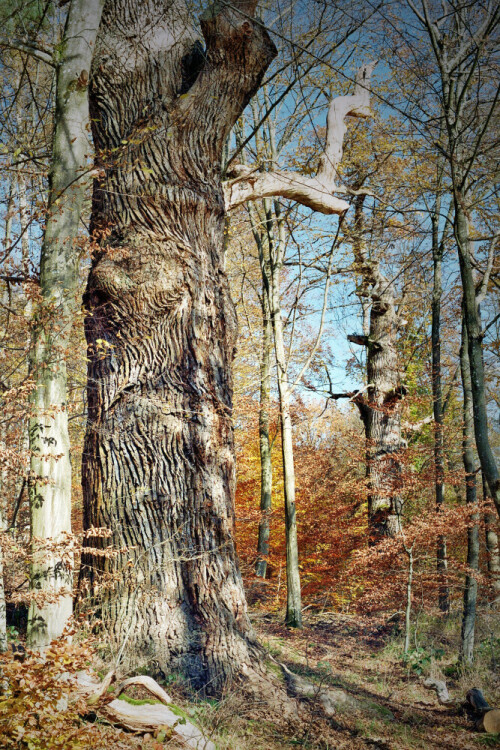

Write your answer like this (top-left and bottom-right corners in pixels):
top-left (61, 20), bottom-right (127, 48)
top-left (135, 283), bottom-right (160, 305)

top-left (83, 612), bottom-right (500, 750)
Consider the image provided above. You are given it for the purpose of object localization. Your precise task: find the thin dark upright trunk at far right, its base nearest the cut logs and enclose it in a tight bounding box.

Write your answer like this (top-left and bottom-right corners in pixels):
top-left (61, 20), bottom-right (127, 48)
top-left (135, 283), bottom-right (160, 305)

top-left (460, 319), bottom-right (479, 664)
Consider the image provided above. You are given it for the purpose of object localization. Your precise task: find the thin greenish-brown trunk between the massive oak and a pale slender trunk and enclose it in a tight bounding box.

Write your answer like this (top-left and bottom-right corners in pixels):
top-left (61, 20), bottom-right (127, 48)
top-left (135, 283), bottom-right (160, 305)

top-left (255, 285), bottom-right (273, 578)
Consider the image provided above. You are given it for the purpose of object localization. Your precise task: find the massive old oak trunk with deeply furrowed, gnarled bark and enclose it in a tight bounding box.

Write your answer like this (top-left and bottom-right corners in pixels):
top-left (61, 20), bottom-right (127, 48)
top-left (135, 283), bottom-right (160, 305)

top-left (83, 0), bottom-right (275, 693)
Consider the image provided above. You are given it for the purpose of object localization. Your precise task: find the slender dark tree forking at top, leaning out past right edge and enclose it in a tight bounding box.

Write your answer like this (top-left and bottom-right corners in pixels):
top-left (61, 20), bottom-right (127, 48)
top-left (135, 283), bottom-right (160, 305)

top-left (410, 2), bottom-right (500, 516)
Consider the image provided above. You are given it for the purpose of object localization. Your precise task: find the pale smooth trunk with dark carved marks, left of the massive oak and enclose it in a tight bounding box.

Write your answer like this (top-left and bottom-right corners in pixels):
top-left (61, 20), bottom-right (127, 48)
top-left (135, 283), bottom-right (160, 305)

top-left (28, 0), bottom-right (103, 648)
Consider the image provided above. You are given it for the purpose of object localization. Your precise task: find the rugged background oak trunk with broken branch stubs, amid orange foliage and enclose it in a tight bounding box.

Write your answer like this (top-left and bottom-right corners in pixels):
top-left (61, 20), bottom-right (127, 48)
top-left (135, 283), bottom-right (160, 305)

top-left (348, 196), bottom-right (406, 543)
